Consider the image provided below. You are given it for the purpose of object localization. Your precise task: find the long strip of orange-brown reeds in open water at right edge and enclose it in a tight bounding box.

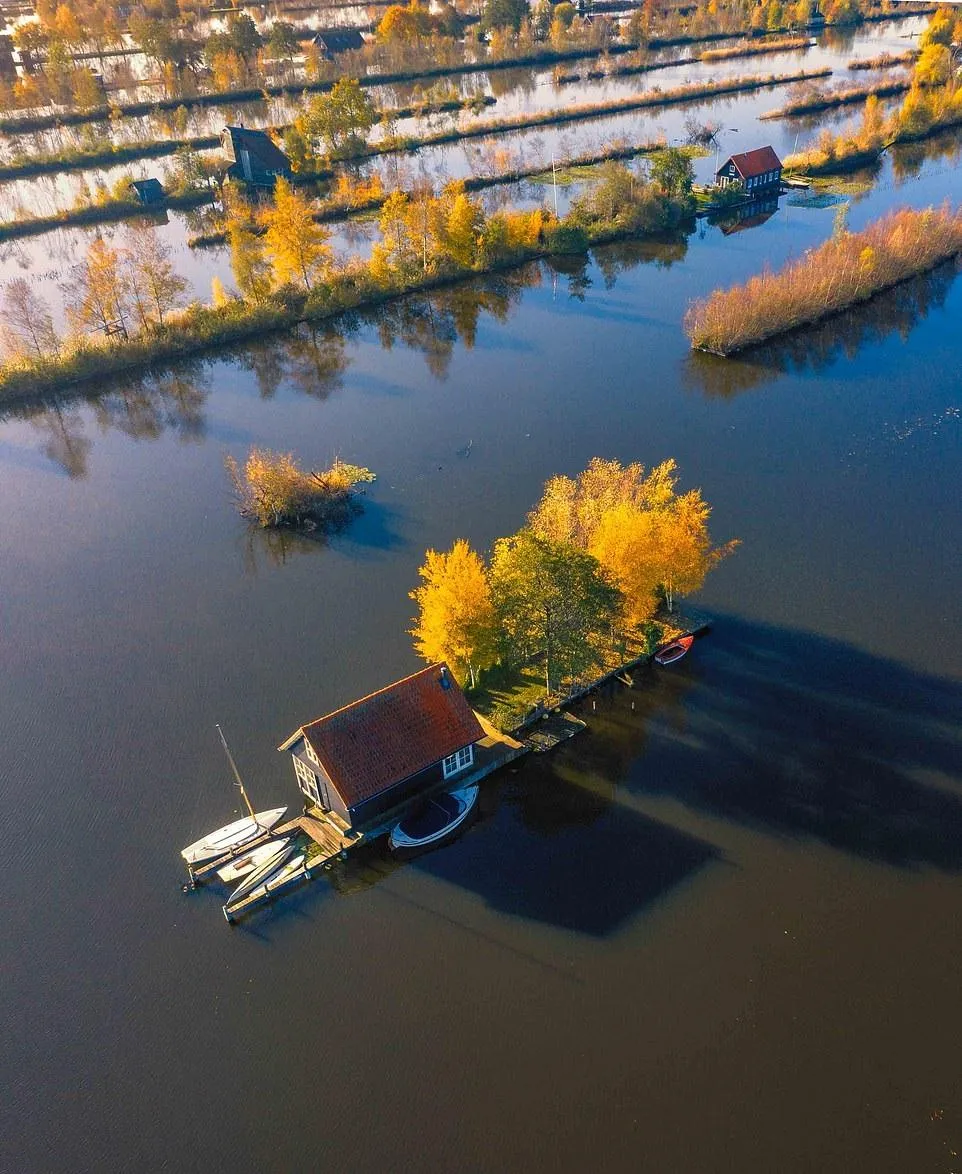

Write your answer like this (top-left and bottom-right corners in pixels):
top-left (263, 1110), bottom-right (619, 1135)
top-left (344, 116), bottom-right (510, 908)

top-left (685, 204), bottom-right (962, 356)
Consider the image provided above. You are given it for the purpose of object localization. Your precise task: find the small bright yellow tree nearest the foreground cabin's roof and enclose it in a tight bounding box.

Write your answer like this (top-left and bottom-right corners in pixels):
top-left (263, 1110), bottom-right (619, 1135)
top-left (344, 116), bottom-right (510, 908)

top-left (411, 538), bottom-right (497, 687)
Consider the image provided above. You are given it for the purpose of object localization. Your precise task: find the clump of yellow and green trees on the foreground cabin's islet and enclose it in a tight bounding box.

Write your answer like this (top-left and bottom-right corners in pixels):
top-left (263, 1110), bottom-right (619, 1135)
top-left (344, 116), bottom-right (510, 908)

top-left (411, 457), bottom-right (738, 730)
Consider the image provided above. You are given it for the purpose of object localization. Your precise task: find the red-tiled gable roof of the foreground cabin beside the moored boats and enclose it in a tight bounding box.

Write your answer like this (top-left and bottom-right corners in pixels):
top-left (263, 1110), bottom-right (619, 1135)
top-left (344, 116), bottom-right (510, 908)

top-left (281, 663), bottom-right (484, 807)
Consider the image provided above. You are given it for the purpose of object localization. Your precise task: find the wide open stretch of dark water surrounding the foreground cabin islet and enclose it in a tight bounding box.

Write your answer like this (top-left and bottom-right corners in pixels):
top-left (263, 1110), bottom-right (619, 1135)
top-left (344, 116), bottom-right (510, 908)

top-left (0, 176), bottom-right (962, 1174)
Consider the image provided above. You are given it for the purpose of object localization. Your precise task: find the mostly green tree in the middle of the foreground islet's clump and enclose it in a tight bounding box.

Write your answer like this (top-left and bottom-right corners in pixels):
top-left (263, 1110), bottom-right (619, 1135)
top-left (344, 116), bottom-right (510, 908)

top-left (490, 529), bottom-right (621, 693)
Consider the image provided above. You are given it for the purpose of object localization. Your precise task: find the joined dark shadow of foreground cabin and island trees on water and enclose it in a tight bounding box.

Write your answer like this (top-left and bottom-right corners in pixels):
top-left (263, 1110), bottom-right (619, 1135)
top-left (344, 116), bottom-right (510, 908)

top-left (413, 616), bottom-right (962, 936)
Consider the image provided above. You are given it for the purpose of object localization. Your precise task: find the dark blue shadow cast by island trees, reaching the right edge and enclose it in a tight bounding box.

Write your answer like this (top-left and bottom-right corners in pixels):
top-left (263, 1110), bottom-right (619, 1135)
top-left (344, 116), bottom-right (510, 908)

top-left (632, 616), bottom-right (962, 871)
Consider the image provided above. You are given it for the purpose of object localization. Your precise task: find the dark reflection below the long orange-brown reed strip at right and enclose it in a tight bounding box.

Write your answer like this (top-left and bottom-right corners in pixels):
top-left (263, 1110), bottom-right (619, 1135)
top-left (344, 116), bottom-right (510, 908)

top-left (682, 262), bottom-right (957, 399)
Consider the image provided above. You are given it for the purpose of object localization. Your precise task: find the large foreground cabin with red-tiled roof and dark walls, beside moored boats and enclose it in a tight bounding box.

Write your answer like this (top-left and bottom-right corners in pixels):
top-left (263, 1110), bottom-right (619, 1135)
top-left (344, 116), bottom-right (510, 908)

top-left (278, 663), bottom-right (484, 828)
